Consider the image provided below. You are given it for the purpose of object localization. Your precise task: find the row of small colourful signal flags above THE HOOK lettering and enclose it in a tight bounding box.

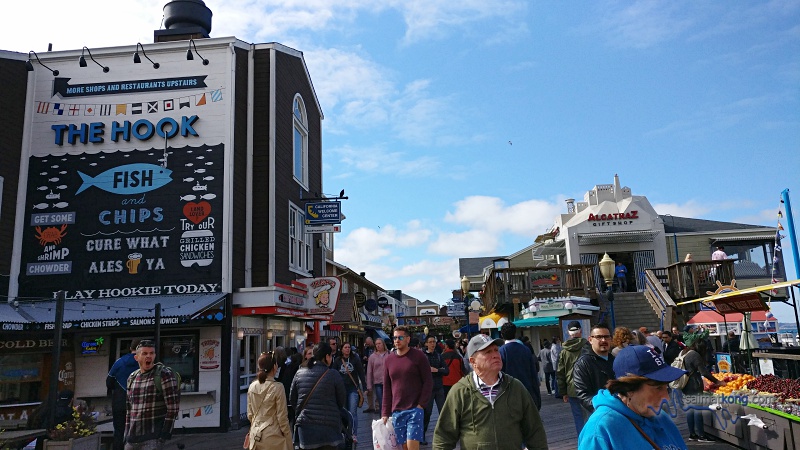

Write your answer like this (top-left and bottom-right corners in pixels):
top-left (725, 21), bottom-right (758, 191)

top-left (36, 89), bottom-right (223, 116)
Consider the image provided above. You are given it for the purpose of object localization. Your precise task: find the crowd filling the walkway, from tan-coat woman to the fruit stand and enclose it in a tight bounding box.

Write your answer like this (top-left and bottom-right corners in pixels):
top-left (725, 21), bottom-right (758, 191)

top-left (233, 321), bottom-right (736, 450)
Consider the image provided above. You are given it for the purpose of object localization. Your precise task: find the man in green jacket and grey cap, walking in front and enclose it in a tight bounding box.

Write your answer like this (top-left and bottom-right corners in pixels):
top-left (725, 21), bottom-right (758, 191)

top-left (433, 334), bottom-right (547, 450)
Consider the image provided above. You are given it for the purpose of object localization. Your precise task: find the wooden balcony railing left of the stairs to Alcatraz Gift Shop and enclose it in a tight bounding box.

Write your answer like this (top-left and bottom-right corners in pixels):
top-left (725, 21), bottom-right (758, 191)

top-left (482, 264), bottom-right (597, 311)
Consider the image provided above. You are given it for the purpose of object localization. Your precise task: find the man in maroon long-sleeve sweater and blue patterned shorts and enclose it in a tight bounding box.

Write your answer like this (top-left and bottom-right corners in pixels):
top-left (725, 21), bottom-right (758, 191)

top-left (381, 326), bottom-right (433, 450)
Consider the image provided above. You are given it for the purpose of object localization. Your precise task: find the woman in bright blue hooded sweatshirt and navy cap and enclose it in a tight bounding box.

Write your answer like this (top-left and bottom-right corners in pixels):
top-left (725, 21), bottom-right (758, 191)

top-left (578, 345), bottom-right (687, 450)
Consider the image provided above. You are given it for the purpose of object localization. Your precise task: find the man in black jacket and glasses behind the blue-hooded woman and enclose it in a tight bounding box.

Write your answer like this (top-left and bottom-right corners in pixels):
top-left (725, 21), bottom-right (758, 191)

top-left (572, 323), bottom-right (616, 412)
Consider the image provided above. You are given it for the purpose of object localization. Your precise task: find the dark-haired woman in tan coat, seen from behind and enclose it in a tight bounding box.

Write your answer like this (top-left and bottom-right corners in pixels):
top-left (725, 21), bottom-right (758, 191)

top-left (247, 352), bottom-right (292, 450)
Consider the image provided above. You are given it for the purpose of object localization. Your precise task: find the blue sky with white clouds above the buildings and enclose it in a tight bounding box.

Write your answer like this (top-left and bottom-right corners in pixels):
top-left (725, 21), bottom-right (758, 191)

top-left (0, 0), bottom-right (800, 321)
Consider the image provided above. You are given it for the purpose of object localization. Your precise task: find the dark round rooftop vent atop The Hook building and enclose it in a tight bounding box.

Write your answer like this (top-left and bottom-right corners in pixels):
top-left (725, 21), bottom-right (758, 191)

top-left (153, 0), bottom-right (211, 42)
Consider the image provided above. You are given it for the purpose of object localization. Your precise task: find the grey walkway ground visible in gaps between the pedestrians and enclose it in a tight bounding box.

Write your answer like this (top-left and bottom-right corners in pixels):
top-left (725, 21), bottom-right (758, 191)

top-left (165, 389), bottom-right (737, 450)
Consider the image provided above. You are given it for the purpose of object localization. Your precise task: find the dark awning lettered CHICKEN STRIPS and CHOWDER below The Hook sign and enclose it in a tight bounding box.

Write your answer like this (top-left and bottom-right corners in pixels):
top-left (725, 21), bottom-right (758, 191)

top-left (0, 293), bottom-right (226, 330)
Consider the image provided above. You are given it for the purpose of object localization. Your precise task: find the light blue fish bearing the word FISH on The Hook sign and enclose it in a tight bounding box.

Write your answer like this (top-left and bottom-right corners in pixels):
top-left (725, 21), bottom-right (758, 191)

top-left (75, 163), bottom-right (172, 195)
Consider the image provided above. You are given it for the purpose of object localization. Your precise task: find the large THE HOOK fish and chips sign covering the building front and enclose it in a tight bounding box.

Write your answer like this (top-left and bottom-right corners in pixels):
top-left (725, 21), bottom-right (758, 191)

top-left (12, 45), bottom-right (231, 299)
